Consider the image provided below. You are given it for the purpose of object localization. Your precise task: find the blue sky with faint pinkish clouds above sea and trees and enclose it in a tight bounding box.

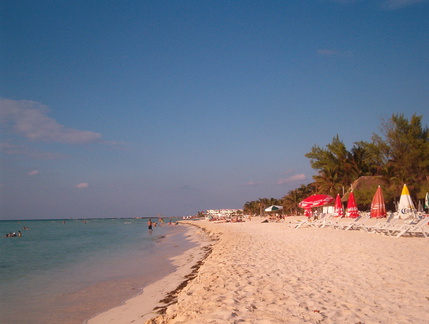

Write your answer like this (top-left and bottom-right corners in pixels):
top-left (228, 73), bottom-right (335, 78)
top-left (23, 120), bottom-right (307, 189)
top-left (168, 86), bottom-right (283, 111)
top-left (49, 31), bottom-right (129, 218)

top-left (0, 0), bottom-right (429, 219)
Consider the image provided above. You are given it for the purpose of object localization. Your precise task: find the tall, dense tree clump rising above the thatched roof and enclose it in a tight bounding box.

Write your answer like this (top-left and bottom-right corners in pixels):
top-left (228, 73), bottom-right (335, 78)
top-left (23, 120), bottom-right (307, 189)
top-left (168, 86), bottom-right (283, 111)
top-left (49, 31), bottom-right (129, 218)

top-left (305, 114), bottom-right (429, 194)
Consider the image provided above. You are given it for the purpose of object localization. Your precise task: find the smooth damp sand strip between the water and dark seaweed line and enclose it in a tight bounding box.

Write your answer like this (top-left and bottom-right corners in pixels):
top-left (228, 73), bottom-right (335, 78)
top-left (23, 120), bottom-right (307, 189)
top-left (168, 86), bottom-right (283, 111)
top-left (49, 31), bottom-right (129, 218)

top-left (83, 221), bottom-right (214, 324)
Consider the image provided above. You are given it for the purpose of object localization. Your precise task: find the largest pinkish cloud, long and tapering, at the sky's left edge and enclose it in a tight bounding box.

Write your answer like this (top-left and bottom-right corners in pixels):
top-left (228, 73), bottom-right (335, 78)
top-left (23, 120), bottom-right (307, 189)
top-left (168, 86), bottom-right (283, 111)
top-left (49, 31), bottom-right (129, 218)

top-left (0, 99), bottom-right (102, 144)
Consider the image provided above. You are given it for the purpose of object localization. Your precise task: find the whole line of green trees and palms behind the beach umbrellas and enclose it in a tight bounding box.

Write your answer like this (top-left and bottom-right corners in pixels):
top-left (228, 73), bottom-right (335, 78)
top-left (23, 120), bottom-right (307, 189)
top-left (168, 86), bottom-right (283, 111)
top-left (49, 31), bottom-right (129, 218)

top-left (243, 114), bottom-right (429, 215)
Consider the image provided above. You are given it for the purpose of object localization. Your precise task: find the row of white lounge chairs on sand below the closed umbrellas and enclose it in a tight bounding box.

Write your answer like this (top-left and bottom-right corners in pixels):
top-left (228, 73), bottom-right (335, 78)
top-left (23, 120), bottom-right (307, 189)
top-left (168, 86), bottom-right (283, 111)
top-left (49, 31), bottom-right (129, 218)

top-left (289, 213), bottom-right (429, 238)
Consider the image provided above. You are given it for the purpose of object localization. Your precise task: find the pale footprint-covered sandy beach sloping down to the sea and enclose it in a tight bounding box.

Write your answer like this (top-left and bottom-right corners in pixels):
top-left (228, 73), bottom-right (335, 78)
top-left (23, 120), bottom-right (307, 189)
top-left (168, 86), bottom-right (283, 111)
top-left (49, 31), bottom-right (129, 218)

top-left (89, 217), bottom-right (429, 324)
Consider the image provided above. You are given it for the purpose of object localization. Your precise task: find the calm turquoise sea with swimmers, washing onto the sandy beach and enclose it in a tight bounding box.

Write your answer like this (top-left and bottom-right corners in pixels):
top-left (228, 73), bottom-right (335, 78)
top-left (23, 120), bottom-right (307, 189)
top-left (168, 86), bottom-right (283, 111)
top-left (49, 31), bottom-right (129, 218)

top-left (0, 219), bottom-right (194, 324)
